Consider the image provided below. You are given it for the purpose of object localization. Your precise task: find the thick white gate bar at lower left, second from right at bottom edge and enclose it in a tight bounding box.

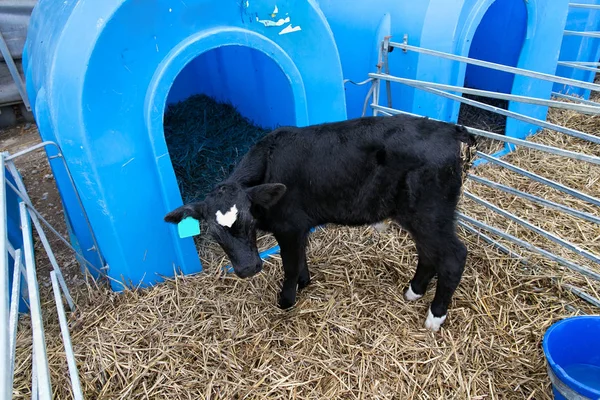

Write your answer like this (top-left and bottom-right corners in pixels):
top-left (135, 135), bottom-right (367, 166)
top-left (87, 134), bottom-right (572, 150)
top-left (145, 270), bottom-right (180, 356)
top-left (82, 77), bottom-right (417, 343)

top-left (19, 201), bottom-right (52, 400)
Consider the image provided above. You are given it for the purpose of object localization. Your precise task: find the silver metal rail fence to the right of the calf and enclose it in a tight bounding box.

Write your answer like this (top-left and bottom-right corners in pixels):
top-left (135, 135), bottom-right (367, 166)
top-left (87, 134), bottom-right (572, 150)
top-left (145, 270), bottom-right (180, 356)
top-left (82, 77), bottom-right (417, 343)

top-left (362, 38), bottom-right (600, 306)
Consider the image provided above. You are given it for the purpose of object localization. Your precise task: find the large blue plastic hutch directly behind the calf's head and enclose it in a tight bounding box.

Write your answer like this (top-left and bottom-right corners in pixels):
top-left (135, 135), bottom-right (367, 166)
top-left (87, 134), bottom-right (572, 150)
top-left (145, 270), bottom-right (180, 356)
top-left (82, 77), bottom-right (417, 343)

top-left (24, 0), bottom-right (346, 290)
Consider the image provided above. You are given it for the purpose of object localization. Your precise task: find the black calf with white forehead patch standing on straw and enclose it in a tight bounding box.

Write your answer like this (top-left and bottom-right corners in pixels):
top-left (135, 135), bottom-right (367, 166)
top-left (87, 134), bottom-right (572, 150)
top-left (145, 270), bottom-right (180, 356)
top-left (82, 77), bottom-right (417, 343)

top-left (165, 115), bottom-right (474, 331)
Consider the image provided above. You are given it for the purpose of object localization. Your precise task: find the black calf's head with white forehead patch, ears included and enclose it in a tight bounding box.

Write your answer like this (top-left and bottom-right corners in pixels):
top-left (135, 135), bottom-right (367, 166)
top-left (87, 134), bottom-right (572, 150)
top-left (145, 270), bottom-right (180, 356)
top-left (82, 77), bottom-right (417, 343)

top-left (165, 183), bottom-right (286, 278)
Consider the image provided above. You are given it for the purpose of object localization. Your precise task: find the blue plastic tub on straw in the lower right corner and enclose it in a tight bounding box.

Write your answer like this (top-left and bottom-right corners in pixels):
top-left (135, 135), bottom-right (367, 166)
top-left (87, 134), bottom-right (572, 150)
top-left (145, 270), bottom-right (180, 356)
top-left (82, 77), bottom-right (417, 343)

top-left (543, 316), bottom-right (600, 399)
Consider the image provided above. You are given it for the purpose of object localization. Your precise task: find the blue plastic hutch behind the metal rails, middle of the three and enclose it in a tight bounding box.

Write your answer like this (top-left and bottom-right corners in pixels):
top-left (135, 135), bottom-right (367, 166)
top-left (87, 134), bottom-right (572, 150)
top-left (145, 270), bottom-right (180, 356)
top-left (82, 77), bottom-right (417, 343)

top-left (319, 0), bottom-right (568, 138)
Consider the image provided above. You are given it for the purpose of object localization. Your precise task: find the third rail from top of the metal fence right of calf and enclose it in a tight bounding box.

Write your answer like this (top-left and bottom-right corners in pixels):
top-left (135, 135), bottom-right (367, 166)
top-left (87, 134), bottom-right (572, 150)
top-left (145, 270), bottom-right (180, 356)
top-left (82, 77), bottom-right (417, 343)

top-left (380, 78), bottom-right (600, 144)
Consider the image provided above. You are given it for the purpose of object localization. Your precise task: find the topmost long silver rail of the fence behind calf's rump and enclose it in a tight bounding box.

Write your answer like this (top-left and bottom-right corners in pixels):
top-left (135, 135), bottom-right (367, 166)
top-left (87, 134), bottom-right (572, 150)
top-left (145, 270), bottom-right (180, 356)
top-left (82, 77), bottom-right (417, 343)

top-left (390, 42), bottom-right (600, 91)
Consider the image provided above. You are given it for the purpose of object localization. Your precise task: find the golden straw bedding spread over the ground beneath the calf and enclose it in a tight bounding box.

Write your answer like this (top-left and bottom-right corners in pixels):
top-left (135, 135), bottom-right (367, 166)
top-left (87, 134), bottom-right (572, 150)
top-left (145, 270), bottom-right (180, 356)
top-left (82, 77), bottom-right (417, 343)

top-left (9, 93), bottom-right (600, 399)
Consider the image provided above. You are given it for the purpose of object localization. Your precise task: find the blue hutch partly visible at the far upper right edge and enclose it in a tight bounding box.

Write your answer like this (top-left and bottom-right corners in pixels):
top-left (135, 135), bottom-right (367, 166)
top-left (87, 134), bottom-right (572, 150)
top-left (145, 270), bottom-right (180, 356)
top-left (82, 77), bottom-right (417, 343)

top-left (554, 0), bottom-right (600, 99)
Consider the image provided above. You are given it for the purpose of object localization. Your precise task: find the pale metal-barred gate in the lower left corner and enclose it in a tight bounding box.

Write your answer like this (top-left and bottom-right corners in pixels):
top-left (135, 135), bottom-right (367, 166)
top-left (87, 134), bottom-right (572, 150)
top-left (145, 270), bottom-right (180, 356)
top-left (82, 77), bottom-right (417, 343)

top-left (0, 142), bottom-right (104, 400)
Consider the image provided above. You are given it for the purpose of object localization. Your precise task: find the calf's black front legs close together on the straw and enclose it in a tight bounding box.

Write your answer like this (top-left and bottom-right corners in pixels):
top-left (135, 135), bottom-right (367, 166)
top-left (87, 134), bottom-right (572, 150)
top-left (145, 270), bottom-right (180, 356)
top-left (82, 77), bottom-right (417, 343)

top-left (275, 232), bottom-right (310, 310)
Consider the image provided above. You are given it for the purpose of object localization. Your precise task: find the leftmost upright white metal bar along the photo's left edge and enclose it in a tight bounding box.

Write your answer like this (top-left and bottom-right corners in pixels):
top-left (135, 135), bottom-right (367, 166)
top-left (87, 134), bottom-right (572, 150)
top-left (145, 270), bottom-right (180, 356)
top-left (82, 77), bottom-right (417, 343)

top-left (0, 154), bottom-right (12, 399)
